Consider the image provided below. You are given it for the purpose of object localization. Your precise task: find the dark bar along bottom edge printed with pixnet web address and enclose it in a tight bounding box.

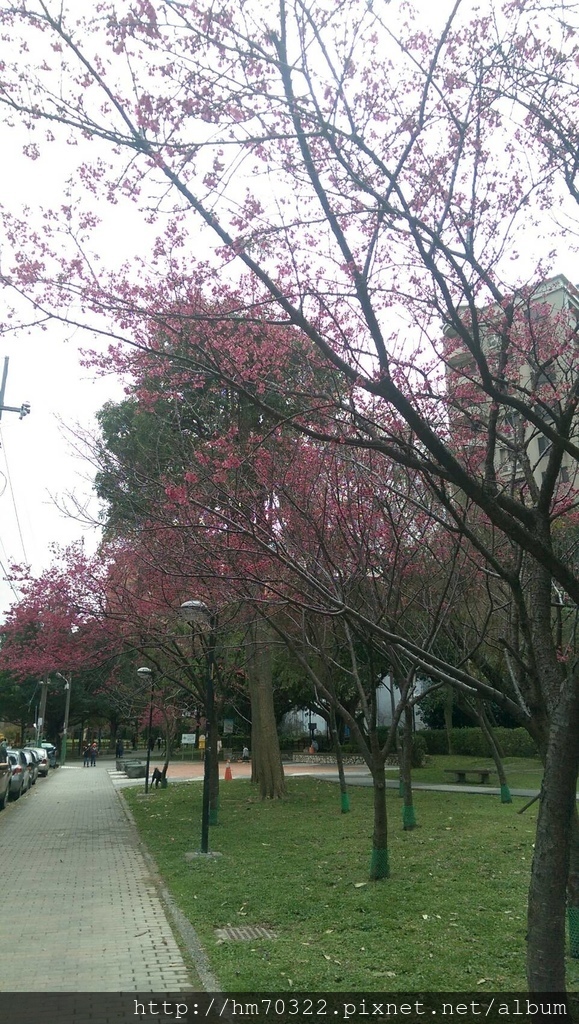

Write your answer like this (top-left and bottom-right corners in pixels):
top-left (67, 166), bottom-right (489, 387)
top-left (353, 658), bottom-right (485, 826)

top-left (0, 992), bottom-right (579, 1024)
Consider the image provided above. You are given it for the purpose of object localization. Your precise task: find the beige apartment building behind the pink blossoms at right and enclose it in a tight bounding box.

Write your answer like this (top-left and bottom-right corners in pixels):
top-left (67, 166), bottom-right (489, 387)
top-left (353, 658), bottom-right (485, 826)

top-left (444, 274), bottom-right (579, 486)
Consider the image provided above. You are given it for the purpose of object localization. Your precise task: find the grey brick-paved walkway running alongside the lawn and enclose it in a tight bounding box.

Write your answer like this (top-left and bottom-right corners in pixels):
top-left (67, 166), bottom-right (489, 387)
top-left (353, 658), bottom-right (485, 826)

top-left (0, 762), bottom-right (199, 992)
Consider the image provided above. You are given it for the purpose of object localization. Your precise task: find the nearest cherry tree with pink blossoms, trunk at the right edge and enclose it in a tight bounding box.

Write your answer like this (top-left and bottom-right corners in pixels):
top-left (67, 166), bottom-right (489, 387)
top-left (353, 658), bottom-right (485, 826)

top-left (0, 0), bottom-right (579, 991)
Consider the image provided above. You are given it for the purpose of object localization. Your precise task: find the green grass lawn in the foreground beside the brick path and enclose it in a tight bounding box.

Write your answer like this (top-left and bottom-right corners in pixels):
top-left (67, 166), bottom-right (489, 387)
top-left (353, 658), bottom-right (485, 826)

top-left (120, 778), bottom-right (579, 992)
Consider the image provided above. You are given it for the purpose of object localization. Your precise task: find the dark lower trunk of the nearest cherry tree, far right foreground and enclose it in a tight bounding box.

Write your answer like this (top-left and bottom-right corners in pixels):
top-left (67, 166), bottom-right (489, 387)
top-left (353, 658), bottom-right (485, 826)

top-left (527, 678), bottom-right (579, 992)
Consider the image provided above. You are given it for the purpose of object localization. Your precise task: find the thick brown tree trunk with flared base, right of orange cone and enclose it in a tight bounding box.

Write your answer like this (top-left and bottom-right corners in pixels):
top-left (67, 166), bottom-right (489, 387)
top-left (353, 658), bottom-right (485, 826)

top-left (247, 616), bottom-right (286, 800)
